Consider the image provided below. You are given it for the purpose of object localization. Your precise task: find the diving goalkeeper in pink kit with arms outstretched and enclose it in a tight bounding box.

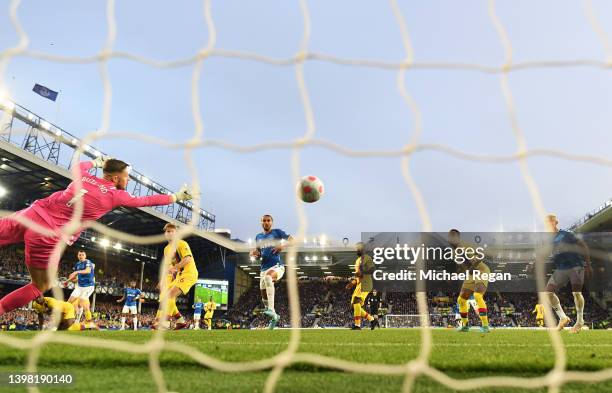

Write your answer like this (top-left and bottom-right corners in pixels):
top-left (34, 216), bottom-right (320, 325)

top-left (0, 157), bottom-right (192, 315)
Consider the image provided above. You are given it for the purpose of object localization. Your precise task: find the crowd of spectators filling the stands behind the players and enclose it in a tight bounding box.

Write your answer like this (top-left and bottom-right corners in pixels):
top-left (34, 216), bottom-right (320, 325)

top-left (0, 247), bottom-right (612, 330)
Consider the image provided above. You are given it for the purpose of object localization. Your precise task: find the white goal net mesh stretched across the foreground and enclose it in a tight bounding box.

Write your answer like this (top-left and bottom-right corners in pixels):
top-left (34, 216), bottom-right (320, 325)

top-left (0, 0), bottom-right (612, 392)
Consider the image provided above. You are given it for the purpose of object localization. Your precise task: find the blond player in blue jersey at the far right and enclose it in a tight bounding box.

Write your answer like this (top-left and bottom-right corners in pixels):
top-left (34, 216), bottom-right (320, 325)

top-left (546, 214), bottom-right (593, 333)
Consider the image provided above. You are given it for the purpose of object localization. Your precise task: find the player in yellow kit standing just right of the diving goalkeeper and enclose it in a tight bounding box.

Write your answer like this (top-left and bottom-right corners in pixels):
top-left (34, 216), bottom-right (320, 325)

top-left (157, 223), bottom-right (198, 330)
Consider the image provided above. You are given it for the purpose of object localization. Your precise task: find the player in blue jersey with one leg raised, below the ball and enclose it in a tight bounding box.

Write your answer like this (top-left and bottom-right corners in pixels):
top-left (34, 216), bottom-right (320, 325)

top-left (250, 214), bottom-right (293, 329)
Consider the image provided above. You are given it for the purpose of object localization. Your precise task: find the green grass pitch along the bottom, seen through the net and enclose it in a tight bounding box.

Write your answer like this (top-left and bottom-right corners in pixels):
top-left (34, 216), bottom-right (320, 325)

top-left (0, 329), bottom-right (612, 393)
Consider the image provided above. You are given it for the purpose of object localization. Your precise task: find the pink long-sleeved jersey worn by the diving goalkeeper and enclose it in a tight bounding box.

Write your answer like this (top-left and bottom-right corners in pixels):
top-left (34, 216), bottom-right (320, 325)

top-left (31, 161), bottom-right (173, 244)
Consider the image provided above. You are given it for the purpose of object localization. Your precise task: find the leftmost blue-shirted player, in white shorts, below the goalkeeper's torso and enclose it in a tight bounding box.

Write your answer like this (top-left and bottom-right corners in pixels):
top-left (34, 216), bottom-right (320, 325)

top-left (68, 250), bottom-right (96, 329)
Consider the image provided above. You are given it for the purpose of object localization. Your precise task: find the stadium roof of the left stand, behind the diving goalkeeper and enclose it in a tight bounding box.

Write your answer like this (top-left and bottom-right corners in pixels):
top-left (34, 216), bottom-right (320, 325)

top-left (0, 102), bottom-right (239, 259)
